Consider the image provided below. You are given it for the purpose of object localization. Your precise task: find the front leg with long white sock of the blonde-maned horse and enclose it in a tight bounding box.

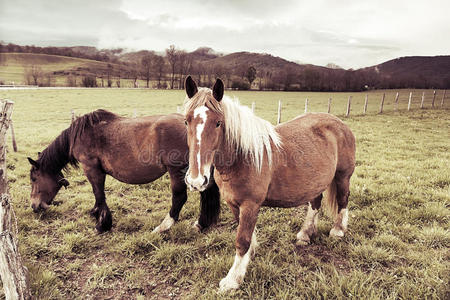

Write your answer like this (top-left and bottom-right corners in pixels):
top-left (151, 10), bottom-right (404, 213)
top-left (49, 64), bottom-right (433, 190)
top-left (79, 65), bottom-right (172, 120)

top-left (219, 201), bottom-right (260, 292)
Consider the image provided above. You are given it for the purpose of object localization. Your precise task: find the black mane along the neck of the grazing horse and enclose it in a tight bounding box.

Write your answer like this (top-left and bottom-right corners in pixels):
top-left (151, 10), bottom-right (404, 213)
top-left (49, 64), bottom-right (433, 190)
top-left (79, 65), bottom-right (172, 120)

top-left (37, 109), bottom-right (119, 174)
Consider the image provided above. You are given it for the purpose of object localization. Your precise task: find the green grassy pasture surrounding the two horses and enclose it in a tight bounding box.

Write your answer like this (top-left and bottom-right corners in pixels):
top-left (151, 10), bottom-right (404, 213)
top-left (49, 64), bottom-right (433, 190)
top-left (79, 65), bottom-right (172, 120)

top-left (0, 89), bottom-right (450, 299)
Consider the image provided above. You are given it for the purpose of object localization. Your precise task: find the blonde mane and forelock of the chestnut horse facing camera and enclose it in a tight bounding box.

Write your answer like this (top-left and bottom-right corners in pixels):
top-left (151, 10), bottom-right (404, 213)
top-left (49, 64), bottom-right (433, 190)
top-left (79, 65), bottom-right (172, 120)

top-left (184, 88), bottom-right (281, 172)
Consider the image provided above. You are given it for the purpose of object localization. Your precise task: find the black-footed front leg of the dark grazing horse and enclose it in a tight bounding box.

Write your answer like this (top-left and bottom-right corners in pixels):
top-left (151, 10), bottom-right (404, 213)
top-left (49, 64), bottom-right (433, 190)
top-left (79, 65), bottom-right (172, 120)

top-left (83, 165), bottom-right (112, 233)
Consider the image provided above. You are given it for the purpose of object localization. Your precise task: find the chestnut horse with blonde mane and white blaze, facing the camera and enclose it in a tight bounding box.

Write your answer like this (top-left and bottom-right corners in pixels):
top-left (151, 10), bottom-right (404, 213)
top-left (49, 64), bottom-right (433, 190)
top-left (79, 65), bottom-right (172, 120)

top-left (185, 77), bottom-right (355, 291)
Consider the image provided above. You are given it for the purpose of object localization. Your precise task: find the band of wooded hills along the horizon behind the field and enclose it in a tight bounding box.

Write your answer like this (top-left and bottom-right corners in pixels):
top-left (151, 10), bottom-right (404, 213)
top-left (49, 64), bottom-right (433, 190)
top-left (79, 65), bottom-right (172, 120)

top-left (0, 42), bottom-right (450, 91)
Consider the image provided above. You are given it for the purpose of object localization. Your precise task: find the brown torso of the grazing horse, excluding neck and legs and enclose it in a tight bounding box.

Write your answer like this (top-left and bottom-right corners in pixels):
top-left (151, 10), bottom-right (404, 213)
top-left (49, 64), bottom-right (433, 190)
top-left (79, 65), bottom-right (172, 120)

top-left (75, 114), bottom-right (188, 183)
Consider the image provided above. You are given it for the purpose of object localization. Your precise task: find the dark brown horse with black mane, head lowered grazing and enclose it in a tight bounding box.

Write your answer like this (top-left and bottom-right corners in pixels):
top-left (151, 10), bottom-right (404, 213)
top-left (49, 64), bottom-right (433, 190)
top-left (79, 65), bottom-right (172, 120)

top-left (28, 110), bottom-right (220, 233)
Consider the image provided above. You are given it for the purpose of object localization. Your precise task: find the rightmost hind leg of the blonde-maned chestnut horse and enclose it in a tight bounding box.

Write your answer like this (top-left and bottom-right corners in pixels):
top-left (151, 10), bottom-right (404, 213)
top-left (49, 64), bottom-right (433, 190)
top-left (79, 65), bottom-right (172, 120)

top-left (330, 174), bottom-right (350, 237)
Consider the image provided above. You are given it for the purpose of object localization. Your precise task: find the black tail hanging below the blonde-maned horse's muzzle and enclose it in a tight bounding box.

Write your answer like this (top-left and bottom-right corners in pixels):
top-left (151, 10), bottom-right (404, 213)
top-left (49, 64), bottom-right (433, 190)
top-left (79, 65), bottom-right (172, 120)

top-left (198, 176), bottom-right (220, 229)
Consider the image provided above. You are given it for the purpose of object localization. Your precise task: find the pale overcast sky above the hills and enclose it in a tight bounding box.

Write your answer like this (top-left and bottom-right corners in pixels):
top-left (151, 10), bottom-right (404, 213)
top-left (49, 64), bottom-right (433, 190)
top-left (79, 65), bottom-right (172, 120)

top-left (0, 0), bottom-right (450, 68)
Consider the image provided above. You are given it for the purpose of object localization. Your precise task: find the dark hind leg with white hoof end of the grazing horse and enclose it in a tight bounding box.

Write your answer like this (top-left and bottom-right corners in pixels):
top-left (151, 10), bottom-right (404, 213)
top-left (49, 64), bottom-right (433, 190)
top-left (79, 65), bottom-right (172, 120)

top-left (153, 168), bottom-right (187, 232)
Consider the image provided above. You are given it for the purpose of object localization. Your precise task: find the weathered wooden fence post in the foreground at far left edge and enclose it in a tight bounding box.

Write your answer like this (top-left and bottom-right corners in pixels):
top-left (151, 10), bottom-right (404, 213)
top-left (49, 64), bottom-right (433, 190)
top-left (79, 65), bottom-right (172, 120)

top-left (0, 100), bottom-right (31, 299)
